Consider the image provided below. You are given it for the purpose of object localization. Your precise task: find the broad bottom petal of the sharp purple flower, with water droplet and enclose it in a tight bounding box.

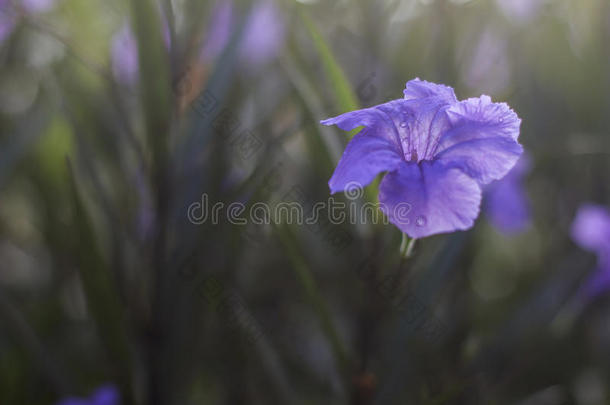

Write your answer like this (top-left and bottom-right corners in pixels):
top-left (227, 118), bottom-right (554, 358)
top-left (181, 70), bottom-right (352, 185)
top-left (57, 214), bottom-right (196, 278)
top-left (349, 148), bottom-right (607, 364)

top-left (379, 161), bottom-right (481, 238)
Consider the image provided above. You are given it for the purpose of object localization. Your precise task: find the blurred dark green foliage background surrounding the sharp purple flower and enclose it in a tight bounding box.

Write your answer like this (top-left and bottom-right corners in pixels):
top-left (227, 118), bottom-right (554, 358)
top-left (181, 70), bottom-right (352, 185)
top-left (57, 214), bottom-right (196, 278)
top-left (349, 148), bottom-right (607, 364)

top-left (0, 0), bottom-right (610, 405)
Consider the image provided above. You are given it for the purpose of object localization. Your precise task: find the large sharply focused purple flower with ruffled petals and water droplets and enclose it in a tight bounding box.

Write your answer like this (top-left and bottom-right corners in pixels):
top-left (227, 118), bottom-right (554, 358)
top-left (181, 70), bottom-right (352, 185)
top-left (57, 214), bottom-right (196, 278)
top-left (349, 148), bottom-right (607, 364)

top-left (321, 79), bottom-right (523, 238)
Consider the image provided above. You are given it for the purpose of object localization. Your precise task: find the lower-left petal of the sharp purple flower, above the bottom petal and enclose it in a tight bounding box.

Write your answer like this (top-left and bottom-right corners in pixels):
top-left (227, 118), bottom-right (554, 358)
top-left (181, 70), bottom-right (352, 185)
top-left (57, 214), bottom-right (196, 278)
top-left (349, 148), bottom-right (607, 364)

top-left (328, 128), bottom-right (402, 194)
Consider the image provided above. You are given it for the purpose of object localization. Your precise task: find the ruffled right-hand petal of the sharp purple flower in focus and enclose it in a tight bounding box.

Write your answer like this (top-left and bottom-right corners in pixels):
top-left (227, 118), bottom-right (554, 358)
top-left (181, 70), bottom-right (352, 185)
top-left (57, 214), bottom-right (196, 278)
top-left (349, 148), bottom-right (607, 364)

top-left (435, 96), bottom-right (523, 184)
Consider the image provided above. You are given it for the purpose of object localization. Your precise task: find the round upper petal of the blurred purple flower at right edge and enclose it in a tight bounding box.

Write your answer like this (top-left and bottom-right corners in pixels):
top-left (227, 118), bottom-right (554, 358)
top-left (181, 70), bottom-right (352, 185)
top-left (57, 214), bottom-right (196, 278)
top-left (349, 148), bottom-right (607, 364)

top-left (571, 204), bottom-right (610, 256)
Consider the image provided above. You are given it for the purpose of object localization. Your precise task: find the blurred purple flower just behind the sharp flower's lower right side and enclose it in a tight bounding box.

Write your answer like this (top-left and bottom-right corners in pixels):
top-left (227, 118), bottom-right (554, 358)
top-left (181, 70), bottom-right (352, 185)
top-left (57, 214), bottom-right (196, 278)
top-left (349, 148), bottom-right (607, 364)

top-left (485, 155), bottom-right (531, 235)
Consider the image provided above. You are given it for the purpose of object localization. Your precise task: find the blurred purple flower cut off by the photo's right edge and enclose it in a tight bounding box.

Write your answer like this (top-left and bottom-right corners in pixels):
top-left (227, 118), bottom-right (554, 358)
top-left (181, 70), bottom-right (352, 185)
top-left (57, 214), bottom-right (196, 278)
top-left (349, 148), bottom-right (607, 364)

top-left (571, 204), bottom-right (610, 297)
